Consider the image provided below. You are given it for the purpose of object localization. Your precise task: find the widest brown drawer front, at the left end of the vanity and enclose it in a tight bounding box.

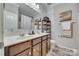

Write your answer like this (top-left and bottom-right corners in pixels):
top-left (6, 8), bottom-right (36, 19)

top-left (9, 41), bottom-right (31, 55)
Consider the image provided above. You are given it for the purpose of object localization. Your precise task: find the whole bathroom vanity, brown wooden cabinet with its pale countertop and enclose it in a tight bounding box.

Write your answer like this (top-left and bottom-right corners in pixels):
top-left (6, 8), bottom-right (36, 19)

top-left (4, 33), bottom-right (50, 56)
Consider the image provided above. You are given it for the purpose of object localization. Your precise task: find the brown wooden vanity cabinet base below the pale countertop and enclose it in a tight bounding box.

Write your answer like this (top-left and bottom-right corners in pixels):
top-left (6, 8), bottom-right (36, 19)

top-left (5, 35), bottom-right (48, 56)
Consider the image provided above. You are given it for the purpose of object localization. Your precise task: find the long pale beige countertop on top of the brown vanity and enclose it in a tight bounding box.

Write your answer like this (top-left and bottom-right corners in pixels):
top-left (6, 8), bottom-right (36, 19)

top-left (4, 33), bottom-right (49, 47)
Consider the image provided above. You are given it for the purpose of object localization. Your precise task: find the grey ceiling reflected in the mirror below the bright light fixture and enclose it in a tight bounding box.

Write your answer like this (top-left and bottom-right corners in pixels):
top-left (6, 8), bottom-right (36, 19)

top-left (19, 3), bottom-right (39, 17)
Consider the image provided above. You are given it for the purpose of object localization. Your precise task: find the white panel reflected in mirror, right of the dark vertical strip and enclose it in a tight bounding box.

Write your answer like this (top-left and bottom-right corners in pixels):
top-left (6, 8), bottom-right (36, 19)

top-left (20, 15), bottom-right (32, 33)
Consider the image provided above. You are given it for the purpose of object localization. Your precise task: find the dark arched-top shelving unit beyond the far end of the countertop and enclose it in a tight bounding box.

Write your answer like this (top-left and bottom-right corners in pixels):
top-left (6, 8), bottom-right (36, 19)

top-left (42, 17), bottom-right (51, 50)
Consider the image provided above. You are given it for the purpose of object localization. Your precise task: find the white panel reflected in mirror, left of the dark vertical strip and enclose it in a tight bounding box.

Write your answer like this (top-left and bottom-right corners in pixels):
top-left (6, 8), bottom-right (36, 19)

top-left (4, 11), bottom-right (18, 33)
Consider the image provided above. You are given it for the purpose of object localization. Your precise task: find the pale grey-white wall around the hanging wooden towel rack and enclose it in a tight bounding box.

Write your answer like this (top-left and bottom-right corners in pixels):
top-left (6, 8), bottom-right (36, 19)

top-left (47, 3), bottom-right (78, 49)
